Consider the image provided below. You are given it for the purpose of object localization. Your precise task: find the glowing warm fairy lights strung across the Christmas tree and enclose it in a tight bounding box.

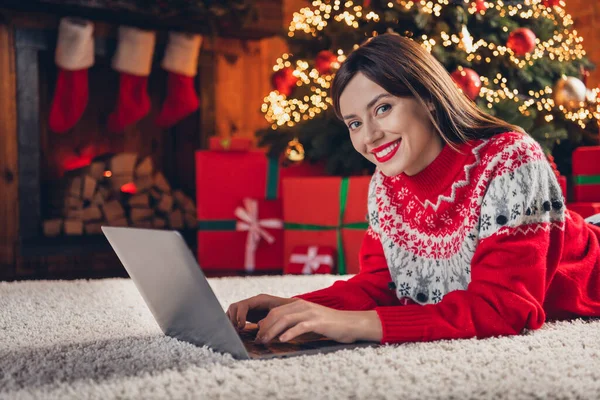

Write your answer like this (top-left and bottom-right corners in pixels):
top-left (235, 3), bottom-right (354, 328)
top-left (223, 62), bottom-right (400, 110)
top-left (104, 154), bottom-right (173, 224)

top-left (262, 0), bottom-right (600, 129)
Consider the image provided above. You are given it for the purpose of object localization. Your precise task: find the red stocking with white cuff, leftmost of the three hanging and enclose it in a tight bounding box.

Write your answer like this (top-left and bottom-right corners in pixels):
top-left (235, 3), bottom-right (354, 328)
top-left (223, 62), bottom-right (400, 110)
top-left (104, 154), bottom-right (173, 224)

top-left (48, 18), bottom-right (94, 133)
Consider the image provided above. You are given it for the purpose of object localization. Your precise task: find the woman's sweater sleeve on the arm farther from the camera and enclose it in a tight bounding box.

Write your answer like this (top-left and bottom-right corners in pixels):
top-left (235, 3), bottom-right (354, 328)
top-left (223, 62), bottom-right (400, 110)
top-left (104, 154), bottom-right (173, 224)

top-left (294, 172), bottom-right (399, 311)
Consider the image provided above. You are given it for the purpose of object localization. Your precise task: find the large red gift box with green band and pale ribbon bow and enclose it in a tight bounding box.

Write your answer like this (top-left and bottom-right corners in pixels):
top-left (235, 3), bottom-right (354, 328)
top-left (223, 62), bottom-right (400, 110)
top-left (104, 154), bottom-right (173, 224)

top-left (196, 150), bottom-right (324, 271)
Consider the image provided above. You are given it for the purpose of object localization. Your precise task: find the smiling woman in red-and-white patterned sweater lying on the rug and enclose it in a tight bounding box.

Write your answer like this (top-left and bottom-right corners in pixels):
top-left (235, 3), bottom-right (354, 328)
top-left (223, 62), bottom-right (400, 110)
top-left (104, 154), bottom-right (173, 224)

top-left (227, 35), bottom-right (600, 343)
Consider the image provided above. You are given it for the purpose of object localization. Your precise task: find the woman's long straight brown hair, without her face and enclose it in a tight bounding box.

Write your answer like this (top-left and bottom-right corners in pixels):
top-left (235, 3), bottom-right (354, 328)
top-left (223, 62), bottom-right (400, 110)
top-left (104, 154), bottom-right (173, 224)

top-left (331, 34), bottom-right (523, 146)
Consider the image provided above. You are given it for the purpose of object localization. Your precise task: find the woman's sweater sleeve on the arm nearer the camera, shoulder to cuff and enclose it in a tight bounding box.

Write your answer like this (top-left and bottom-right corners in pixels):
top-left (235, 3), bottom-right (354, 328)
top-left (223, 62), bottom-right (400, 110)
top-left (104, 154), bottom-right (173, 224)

top-left (376, 138), bottom-right (565, 343)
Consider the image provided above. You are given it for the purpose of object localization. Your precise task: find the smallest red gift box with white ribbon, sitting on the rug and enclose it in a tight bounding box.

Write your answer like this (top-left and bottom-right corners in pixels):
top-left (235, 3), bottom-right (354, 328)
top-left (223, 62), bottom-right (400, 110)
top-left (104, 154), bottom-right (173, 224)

top-left (286, 246), bottom-right (336, 275)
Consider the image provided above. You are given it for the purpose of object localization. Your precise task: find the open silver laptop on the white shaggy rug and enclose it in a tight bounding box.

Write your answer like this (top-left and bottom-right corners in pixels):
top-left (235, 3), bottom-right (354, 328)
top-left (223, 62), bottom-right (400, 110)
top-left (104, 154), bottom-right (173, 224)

top-left (102, 226), bottom-right (377, 359)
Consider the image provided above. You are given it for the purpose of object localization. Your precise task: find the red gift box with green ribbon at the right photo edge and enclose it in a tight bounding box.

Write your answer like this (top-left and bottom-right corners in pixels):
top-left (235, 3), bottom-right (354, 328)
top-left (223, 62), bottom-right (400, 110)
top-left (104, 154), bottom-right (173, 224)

top-left (572, 146), bottom-right (600, 203)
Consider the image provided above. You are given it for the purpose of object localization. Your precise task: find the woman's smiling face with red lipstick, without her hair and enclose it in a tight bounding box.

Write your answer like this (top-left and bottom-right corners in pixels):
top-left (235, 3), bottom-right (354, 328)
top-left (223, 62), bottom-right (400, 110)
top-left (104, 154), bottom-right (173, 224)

top-left (340, 72), bottom-right (443, 176)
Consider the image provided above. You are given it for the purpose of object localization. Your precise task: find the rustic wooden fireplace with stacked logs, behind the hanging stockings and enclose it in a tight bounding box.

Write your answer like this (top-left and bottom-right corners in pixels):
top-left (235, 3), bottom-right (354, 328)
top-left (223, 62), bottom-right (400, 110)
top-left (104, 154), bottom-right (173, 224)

top-left (0, 0), bottom-right (290, 280)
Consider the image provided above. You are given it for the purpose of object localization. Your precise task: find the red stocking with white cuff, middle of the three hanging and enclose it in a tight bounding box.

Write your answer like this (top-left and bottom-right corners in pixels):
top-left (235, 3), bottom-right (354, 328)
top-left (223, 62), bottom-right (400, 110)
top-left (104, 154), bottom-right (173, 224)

top-left (108, 26), bottom-right (156, 132)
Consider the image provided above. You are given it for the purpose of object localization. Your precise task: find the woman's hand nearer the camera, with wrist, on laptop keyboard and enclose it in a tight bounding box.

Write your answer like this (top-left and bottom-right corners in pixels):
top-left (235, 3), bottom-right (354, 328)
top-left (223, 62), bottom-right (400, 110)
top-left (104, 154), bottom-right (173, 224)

top-left (256, 299), bottom-right (383, 343)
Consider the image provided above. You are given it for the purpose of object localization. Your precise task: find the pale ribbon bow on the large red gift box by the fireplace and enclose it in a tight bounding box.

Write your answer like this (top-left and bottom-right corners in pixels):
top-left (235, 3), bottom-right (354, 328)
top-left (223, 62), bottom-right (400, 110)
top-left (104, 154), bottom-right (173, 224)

top-left (234, 198), bottom-right (283, 271)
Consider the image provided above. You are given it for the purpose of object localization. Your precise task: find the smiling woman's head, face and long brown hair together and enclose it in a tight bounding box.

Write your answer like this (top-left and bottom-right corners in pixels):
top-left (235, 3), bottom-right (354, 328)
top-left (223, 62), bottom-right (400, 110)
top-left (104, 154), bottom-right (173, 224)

top-left (332, 35), bottom-right (522, 176)
